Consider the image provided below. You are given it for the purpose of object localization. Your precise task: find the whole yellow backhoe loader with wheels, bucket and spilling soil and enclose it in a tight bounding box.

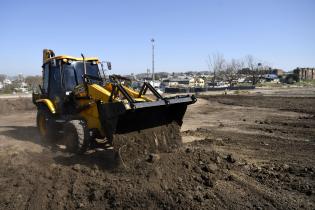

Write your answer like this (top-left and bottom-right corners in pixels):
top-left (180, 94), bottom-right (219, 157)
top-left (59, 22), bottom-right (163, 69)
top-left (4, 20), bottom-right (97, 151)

top-left (33, 49), bottom-right (196, 153)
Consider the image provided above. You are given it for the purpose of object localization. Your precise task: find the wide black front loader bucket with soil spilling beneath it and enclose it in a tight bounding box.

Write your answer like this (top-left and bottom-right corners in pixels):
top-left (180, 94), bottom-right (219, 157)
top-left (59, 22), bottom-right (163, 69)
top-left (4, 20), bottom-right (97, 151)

top-left (98, 96), bottom-right (196, 152)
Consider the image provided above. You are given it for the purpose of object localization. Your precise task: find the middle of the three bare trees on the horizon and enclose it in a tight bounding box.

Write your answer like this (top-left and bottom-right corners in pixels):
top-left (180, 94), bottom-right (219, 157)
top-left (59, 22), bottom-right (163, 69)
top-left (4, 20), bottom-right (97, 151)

top-left (222, 59), bottom-right (244, 87)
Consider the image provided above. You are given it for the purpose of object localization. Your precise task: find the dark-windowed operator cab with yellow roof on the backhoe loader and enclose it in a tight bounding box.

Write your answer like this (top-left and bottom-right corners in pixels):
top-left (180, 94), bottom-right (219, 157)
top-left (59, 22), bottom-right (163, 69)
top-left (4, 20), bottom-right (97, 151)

top-left (40, 49), bottom-right (104, 113)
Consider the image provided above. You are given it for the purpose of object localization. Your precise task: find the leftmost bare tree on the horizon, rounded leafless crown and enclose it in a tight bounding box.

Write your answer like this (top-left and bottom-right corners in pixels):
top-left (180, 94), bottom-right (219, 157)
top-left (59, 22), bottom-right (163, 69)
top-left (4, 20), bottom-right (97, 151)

top-left (207, 52), bottom-right (225, 87)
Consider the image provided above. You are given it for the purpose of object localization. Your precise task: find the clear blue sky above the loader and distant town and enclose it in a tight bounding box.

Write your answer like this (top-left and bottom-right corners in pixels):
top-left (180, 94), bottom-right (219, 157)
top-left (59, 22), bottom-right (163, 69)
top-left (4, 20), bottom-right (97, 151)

top-left (0, 0), bottom-right (315, 75)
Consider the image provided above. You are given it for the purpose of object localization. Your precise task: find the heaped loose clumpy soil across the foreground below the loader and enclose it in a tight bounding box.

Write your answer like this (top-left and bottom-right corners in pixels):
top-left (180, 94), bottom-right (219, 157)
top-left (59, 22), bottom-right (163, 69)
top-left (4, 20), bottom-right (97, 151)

top-left (0, 136), bottom-right (314, 210)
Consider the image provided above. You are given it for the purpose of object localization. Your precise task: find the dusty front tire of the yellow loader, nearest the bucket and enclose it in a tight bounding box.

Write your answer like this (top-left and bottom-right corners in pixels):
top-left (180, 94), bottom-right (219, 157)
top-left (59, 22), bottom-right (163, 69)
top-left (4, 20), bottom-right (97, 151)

top-left (64, 120), bottom-right (91, 154)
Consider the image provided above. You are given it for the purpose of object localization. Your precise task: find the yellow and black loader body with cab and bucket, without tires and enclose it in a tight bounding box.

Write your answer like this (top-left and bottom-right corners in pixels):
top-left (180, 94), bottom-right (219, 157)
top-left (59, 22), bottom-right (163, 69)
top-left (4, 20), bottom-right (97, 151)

top-left (33, 49), bottom-right (196, 151)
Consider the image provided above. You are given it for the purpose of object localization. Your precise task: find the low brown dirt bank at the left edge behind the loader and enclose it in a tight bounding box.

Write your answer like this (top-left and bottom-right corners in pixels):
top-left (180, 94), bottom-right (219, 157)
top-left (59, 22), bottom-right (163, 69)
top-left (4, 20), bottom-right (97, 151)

top-left (0, 97), bottom-right (35, 114)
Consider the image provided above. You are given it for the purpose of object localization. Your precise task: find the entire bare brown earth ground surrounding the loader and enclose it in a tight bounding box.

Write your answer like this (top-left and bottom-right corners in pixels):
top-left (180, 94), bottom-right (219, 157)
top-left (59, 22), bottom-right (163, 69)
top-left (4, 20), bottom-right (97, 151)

top-left (0, 89), bottom-right (315, 209)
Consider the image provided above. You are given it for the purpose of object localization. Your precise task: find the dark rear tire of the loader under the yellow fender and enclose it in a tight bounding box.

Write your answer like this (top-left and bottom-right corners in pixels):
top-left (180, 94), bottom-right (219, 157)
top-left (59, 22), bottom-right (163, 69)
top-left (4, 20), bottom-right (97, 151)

top-left (36, 106), bottom-right (58, 141)
